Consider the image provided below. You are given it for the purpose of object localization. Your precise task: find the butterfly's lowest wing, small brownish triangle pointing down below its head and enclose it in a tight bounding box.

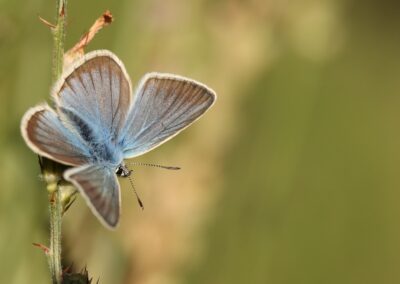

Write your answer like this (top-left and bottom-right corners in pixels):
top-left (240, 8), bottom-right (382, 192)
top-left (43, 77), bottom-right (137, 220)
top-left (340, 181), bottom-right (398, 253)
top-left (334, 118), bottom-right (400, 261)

top-left (64, 165), bottom-right (121, 228)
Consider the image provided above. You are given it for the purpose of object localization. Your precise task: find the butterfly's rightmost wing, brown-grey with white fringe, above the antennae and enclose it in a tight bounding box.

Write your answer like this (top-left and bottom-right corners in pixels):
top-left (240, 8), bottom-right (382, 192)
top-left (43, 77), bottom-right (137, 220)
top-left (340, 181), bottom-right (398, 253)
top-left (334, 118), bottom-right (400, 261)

top-left (121, 73), bottom-right (215, 158)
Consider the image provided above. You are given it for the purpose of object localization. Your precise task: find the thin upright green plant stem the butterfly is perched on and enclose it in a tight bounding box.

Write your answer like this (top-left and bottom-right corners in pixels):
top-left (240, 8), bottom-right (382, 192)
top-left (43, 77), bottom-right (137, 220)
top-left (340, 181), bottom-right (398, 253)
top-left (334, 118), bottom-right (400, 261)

top-left (47, 0), bottom-right (67, 284)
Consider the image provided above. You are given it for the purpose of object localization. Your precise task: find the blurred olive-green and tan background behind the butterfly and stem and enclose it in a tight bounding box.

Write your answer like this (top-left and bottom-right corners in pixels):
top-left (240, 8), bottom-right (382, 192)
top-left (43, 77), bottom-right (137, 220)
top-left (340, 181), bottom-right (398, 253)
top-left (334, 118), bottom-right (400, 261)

top-left (0, 0), bottom-right (400, 284)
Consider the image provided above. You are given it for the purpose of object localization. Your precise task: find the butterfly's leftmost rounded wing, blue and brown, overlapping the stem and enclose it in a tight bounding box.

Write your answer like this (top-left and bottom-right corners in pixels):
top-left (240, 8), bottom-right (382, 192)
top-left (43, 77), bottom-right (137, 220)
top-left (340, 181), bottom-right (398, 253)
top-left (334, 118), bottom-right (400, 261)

top-left (21, 105), bottom-right (90, 166)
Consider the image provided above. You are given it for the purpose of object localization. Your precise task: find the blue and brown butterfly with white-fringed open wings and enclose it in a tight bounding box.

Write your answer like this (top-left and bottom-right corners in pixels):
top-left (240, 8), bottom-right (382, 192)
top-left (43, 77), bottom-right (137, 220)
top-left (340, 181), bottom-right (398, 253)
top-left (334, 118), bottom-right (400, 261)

top-left (21, 50), bottom-right (216, 229)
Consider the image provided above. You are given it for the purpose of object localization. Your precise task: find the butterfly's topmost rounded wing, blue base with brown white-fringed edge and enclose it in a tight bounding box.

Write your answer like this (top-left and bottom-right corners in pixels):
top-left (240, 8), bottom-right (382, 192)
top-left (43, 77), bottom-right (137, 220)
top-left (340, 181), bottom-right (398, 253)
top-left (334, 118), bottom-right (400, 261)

top-left (53, 51), bottom-right (131, 141)
